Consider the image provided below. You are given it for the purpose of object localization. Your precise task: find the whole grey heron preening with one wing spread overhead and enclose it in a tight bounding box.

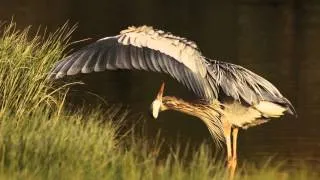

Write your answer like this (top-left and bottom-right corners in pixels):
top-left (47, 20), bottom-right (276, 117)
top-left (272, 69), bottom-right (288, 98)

top-left (50, 25), bottom-right (296, 176)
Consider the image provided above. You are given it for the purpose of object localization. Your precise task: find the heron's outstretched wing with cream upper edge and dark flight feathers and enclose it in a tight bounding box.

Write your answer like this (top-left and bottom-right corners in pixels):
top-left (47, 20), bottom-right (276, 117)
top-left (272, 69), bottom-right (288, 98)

top-left (50, 26), bottom-right (217, 100)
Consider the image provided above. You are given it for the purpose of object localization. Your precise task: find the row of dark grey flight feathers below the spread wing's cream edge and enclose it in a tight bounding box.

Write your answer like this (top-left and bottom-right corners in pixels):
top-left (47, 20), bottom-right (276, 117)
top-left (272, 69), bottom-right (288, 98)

top-left (52, 36), bottom-right (215, 99)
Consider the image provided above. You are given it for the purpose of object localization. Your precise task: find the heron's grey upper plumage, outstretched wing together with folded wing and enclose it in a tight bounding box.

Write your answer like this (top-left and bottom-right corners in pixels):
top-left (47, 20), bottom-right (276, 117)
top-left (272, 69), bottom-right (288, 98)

top-left (51, 26), bottom-right (295, 114)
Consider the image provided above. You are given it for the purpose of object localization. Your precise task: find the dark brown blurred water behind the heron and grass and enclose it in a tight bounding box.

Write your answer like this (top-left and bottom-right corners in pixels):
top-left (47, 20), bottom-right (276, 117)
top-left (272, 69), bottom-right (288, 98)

top-left (0, 0), bottom-right (320, 168)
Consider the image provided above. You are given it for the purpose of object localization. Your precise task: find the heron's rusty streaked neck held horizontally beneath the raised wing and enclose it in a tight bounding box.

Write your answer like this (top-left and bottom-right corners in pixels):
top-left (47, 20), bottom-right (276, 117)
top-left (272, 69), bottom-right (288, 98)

top-left (161, 96), bottom-right (219, 119)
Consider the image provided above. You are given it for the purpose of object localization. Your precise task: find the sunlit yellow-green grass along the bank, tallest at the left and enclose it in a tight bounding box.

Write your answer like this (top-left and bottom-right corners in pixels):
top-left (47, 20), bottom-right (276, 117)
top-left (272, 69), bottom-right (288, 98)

top-left (0, 23), bottom-right (317, 180)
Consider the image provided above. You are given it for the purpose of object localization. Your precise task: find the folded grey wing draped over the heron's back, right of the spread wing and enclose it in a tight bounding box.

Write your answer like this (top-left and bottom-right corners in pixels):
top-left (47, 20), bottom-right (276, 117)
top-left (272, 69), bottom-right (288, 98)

top-left (207, 59), bottom-right (295, 114)
